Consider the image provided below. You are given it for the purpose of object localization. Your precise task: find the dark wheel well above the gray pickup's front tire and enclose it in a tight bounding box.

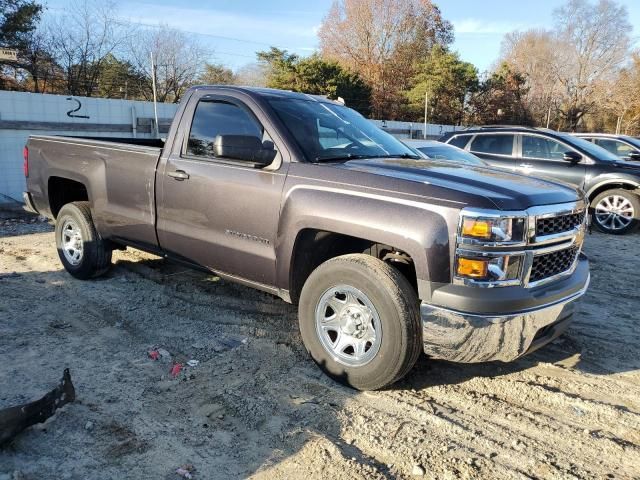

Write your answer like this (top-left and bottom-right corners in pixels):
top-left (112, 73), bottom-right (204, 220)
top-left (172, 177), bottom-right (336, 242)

top-left (289, 229), bottom-right (418, 303)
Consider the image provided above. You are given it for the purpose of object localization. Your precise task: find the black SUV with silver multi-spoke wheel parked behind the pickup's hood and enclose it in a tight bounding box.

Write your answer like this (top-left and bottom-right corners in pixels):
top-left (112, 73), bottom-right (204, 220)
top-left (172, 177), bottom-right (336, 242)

top-left (440, 126), bottom-right (640, 234)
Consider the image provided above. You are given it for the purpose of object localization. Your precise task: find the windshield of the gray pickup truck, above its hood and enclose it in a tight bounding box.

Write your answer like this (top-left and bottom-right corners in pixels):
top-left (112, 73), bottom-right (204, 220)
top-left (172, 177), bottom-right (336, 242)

top-left (269, 98), bottom-right (420, 162)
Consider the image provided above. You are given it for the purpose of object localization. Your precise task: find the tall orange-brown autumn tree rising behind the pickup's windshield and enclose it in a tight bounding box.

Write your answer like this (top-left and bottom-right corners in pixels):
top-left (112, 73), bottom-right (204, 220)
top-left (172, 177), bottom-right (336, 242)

top-left (318, 0), bottom-right (453, 118)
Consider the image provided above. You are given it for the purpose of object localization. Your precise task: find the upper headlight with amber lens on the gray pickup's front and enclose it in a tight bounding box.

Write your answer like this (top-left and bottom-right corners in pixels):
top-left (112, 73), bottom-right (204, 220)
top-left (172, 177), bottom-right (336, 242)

top-left (458, 215), bottom-right (526, 243)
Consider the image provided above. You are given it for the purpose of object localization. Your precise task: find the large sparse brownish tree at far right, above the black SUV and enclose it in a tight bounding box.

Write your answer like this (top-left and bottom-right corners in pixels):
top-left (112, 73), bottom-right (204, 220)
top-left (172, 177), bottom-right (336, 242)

top-left (502, 0), bottom-right (631, 131)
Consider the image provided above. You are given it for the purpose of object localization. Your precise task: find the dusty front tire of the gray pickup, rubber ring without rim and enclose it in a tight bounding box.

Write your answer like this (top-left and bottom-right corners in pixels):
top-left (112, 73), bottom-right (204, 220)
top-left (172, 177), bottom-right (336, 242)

top-left (298, 254), bottom-right (422, 390)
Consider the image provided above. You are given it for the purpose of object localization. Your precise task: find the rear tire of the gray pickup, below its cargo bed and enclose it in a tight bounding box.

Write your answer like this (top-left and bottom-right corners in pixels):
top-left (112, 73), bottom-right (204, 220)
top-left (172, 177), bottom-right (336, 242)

top-left (56, 202), bottom-right (111, 280)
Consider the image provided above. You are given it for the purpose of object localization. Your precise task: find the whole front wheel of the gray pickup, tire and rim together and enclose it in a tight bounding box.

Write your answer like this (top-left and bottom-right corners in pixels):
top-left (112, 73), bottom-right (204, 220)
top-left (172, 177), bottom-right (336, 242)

top-left (299, 254), bottom-right (422, 390)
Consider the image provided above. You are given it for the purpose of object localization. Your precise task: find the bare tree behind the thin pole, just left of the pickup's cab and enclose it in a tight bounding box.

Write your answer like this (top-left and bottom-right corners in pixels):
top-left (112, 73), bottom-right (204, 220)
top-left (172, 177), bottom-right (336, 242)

top-left (128, 25), bottom-right (212, 102)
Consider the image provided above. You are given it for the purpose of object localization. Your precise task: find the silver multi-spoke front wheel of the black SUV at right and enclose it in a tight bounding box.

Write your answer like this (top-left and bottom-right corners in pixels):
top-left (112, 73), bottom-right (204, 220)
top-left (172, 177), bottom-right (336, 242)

top-left (591, 189), bottom-right (640, 235)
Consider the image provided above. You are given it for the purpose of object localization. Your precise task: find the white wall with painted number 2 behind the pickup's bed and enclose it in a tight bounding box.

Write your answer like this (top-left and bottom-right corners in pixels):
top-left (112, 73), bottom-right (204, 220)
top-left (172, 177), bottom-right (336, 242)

top-left (0, 91), bottom-right (177, 203)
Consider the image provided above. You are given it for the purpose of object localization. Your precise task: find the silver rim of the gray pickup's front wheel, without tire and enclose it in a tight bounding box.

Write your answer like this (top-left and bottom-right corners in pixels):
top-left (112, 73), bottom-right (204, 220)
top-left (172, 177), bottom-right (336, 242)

top-left (315, 285), bottom-right (382, 367)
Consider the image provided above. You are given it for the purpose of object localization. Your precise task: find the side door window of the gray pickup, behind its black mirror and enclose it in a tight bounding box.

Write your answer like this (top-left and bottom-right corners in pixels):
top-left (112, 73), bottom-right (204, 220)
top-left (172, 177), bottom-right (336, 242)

top-left (186, 100), bottom-right (275, 162)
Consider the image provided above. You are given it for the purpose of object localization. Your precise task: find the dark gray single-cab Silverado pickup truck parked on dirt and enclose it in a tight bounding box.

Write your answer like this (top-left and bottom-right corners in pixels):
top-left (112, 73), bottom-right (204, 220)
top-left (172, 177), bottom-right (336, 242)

top-left (25, 86), bottom-right (589, 389)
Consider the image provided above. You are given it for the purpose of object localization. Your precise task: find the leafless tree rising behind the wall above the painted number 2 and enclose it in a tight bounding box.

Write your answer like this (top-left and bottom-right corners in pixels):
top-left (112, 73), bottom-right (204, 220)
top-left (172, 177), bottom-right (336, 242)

top-left (47, 0), bottom-right (127, 97)
